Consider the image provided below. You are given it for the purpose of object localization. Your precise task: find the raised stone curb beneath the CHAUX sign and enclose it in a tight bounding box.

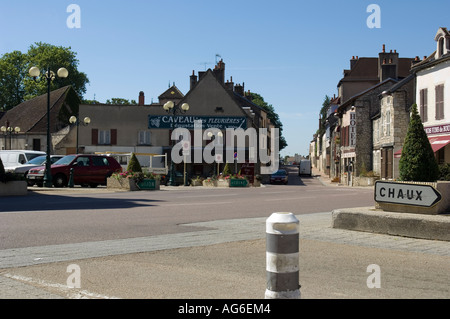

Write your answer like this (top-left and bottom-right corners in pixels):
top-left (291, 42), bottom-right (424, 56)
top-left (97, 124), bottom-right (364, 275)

top-left (332, 207), bottom-right (450, 241)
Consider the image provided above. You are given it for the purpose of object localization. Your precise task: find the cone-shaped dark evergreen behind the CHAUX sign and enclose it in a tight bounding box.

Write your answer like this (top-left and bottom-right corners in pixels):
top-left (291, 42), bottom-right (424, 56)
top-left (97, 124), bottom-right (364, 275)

top-left (399, 104), bottom-right (439, 182)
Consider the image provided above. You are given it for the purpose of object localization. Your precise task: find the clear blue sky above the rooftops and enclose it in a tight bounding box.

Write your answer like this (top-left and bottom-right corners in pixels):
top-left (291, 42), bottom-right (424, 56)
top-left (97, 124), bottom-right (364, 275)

top-left (0, 0), bottom-right (450, 156)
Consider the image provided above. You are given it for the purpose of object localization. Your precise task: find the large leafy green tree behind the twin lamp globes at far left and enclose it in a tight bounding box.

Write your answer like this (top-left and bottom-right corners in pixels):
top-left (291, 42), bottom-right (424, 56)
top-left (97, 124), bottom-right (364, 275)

top-left (0, 42), bottom-right (89, 111)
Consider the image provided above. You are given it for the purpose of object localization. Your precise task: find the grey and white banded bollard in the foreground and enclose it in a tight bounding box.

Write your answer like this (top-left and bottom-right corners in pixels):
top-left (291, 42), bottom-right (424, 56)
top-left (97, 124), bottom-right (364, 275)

top-left (265, 213), bottom-right (300, 299)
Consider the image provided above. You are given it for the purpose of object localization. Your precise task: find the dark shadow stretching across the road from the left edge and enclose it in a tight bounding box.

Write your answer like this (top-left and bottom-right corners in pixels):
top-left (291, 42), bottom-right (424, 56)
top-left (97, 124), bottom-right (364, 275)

top-left (0, 194), bottom-right (163, 214)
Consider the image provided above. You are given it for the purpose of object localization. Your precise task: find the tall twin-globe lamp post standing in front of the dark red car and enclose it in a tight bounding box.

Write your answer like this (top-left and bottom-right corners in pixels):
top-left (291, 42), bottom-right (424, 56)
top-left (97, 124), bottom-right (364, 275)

top-left (29, 66), bottom-right (69, 187)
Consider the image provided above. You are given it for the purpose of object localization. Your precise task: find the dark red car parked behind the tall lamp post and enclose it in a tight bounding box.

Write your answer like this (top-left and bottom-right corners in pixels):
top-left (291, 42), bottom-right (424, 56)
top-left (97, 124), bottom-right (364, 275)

top-left (27, 154), bottom-right (122, 187)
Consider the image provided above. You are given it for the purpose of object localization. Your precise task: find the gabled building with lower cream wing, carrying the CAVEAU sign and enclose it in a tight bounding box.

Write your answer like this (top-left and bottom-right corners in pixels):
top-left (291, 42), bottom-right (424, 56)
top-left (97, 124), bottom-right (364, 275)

top-left (79, 61), bottom-right (272, 180)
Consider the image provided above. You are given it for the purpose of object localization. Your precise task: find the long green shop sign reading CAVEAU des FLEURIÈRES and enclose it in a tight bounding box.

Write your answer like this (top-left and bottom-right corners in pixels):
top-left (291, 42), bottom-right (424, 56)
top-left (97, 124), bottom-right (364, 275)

top-left (148, 115), bottom-right (247, 130)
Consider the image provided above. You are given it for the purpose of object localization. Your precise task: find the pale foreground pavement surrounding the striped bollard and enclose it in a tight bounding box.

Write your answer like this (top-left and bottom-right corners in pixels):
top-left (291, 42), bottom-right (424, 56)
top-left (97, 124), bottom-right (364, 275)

top-left (0, 213), bottom-right (450, 299)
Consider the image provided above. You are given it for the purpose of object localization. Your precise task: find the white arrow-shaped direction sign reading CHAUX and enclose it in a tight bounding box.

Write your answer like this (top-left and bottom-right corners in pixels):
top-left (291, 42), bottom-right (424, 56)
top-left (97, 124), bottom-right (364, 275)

top-left (375, 181), bottom-right (442, 207)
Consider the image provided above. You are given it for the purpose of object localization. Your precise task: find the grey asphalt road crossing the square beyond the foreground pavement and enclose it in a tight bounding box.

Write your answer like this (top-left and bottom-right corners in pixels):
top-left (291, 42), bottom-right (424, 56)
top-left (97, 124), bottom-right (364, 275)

top-left (0, 167), bottom-right (373, 249)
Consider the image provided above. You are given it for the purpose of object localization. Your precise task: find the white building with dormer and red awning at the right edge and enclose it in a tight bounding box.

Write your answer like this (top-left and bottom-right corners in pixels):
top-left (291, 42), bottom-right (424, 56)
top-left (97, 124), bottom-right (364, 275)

top-left (408, 27), bottom-right (450, 164)
